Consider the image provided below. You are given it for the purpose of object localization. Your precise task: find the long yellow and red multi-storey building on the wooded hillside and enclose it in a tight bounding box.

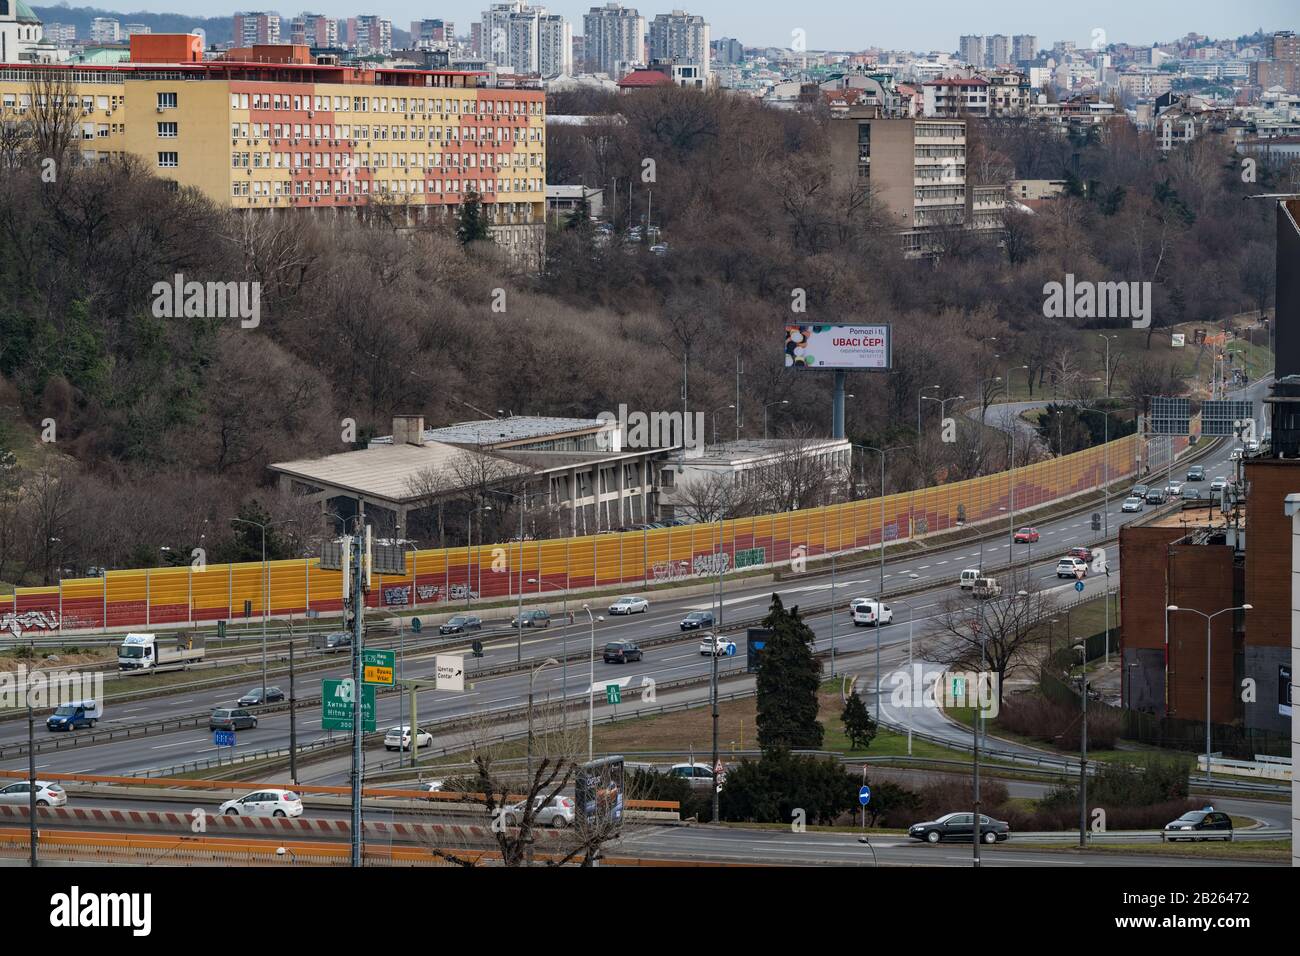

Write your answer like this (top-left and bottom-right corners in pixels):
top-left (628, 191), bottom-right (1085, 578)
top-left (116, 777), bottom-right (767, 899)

top-left (0, 34), bottom-right (546, 254)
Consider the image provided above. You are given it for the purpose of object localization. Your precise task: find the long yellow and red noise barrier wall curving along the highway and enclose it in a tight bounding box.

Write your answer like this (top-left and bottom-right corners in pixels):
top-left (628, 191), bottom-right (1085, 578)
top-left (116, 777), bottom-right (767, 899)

top-left (0, 436), bottom-right (1139, 636)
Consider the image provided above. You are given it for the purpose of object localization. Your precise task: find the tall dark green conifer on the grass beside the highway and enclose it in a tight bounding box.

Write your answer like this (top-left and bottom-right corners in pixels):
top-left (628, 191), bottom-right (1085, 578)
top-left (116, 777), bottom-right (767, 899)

top-left (758, 594), bottom-right (823, 753)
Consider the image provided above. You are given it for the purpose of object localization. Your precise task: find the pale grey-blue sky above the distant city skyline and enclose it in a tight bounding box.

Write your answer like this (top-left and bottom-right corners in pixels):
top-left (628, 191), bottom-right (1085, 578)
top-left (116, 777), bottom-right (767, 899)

top-left (45, 0), bottom-right (1300, 51)
